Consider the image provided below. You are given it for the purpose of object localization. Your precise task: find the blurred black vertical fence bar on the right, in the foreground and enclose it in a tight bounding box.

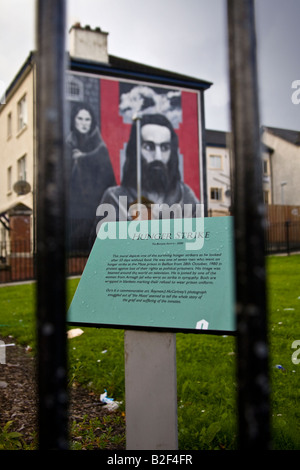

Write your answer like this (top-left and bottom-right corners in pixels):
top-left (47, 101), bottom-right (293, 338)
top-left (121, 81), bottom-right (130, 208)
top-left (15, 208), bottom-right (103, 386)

top-left (227, 0), bottom-right (270, 450)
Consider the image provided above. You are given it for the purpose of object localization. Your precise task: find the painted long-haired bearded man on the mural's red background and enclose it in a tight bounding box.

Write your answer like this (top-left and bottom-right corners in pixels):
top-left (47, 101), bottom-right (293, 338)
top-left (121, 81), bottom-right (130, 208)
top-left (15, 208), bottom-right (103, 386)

top-left (101, 114), bottom-right (199, 220)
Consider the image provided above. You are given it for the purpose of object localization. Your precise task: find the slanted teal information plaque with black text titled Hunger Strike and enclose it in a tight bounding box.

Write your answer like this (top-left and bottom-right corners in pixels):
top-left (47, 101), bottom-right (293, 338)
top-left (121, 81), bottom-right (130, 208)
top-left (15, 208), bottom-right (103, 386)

top-left (68, 217), bottom-right (235, 334)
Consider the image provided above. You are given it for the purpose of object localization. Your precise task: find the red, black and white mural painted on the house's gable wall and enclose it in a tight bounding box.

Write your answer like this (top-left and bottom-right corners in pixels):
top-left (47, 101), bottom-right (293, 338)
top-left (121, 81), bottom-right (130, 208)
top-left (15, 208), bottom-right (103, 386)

top-left (66, 72), bottom-right (203, 252)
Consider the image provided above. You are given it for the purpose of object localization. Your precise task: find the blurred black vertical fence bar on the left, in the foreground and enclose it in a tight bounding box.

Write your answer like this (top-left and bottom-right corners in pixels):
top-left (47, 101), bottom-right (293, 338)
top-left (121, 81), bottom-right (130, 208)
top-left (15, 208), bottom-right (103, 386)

top-left (36, 0), bottom-right (68, 450)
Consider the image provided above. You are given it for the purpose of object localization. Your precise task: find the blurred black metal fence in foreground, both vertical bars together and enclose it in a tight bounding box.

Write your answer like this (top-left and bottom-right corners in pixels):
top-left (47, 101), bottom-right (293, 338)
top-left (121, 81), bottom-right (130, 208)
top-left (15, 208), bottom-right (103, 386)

top-left (31, 0), bottom-right (269, 450)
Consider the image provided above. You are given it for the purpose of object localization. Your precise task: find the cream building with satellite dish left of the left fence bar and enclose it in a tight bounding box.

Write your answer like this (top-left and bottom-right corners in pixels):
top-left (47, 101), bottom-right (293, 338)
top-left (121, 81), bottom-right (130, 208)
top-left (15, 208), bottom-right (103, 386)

top-left (0, 54), bottom-right (35, 256)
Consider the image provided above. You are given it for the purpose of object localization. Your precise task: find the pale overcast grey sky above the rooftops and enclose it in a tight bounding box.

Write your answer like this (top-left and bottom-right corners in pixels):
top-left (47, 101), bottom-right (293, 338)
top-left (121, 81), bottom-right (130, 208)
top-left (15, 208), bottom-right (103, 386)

top-left (0, 0), bottom-right (300, 131)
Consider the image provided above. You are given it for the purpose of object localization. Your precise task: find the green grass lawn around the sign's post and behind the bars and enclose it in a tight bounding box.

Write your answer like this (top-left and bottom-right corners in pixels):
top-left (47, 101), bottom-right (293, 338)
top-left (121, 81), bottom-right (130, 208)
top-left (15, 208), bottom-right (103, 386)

top-left (0, 255), bottom-right (300, 450)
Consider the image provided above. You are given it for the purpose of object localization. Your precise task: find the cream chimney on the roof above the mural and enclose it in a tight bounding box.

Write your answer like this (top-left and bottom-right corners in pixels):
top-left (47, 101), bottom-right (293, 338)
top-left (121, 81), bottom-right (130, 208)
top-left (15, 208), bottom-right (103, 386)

top-left (69, 23), bottom-right (109, 63)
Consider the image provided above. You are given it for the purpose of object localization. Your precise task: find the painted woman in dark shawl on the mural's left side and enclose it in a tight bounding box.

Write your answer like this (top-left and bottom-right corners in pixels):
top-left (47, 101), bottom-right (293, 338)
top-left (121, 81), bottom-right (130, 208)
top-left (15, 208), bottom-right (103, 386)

top-left (66, 103), bottom-right (116, 252)
